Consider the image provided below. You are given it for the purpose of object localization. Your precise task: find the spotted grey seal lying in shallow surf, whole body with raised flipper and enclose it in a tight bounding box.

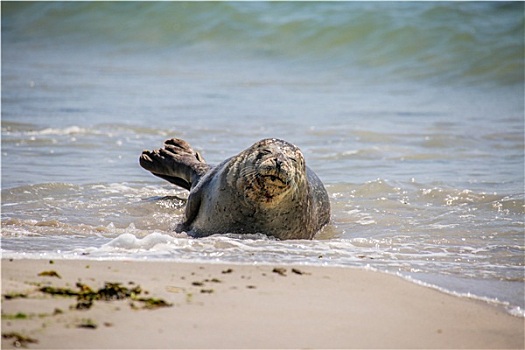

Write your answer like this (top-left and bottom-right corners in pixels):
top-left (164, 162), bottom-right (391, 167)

top-left (139, 139), bottom-right (330, 240)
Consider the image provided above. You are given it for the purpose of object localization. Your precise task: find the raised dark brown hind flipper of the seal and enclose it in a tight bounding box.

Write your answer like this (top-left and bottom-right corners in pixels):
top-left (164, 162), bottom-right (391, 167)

top-left (139, 139), bottom-right (211, 190)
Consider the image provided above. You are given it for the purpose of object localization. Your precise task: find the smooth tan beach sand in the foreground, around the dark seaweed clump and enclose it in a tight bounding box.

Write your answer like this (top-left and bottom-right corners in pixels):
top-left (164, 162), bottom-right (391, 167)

top-left (2, 259), bottom-right (524, 349)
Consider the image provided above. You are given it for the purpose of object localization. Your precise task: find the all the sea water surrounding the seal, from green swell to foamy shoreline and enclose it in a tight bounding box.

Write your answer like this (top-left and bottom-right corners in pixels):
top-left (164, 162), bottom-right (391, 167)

top-left (1, 2), bottom-right (525, 316)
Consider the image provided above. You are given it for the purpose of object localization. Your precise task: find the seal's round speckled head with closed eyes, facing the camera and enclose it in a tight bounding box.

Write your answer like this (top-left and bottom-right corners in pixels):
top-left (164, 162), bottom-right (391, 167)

top-left (232, 139), bottom-right (306, 207)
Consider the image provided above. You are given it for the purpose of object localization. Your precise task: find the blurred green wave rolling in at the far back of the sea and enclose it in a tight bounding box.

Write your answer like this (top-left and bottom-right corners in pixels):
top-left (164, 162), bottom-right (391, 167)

top-left (2, 2), bottom-right (524, 85)
